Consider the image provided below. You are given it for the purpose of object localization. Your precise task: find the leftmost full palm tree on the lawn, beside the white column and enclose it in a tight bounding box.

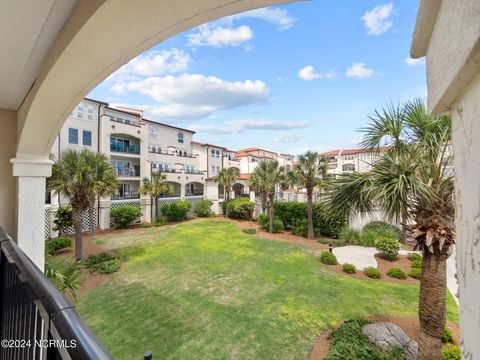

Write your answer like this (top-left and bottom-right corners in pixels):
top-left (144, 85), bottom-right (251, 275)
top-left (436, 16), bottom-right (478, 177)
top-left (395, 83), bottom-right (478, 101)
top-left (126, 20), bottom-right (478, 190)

top-left (47, 149), bottom-right (116, 260)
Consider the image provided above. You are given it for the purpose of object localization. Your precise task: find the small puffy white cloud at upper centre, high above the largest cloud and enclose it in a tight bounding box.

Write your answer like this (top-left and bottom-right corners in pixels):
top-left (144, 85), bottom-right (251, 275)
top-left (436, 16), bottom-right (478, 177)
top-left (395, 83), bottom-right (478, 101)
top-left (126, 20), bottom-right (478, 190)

top-left (187, 24), bottom-right (253, 48)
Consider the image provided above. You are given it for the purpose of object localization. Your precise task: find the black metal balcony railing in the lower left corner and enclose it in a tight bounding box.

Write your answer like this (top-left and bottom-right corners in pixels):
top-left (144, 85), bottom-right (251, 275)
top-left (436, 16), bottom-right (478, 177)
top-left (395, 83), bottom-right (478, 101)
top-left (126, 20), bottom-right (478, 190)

top-left (0, 227), bottom-right (112, 360)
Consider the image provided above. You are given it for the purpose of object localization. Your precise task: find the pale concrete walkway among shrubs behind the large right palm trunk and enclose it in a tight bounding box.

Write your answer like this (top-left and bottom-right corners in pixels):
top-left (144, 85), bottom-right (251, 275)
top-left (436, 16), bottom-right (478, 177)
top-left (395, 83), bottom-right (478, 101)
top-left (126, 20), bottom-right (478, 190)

top-left (333, 246), bottom-right (458, 304)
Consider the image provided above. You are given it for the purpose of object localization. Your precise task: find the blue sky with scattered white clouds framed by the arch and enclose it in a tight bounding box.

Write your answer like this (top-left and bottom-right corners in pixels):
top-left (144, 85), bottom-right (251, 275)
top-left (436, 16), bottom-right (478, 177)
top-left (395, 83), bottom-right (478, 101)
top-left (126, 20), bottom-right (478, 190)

top-left (89, 0), bottom-right (426, 154)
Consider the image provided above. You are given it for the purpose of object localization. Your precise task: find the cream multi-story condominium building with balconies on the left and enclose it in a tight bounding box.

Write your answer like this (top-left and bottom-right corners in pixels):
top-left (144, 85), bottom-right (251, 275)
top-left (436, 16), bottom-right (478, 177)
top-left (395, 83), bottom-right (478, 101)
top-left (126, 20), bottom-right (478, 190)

top-left (46, 98), bottom-right (293, 236)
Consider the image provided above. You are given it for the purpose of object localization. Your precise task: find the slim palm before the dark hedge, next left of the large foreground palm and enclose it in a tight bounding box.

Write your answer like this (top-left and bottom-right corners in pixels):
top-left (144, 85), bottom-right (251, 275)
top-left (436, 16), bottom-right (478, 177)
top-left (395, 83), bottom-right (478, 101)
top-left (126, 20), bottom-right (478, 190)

top-left (290, 151), bottom-right (326, 239)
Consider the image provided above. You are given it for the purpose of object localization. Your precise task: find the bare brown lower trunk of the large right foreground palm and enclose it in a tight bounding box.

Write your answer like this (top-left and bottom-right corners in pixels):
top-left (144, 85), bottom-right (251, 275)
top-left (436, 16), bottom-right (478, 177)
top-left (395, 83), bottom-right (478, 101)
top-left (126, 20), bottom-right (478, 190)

top-left (417, 248), bottom-right (447, 360)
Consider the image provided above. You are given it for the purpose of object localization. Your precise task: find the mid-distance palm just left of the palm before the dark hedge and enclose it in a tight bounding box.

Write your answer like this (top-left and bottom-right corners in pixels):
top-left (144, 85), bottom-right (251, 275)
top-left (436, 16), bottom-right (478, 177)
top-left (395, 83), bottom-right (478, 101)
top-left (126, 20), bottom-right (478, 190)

top-left (252, 160), bottom-right (286, 232)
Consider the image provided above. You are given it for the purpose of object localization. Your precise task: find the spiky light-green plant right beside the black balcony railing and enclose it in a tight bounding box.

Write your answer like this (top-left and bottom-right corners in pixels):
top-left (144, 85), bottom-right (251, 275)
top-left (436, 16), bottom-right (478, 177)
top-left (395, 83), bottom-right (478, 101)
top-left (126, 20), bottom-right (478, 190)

top-left (45, 256), bottom-right (83, 299)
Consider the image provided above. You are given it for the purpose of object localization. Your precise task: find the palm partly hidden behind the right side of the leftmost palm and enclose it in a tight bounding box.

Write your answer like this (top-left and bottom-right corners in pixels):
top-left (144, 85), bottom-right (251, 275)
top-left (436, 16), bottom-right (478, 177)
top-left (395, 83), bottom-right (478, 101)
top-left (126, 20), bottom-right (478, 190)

top-left (84, 151), bottom-right (118, 235)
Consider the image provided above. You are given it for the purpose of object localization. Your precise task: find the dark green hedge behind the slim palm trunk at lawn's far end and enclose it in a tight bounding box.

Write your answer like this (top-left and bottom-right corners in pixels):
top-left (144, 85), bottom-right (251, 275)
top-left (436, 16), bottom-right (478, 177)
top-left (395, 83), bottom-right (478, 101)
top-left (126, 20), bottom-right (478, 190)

top-left (274, 202), bottom-right (347, 238)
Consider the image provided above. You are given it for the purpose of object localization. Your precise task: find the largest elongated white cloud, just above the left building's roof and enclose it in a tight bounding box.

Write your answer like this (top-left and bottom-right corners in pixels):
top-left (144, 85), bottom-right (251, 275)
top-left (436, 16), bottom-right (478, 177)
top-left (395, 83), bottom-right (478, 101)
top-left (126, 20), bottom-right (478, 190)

top-left (112, 74), bottom-right (270, 119)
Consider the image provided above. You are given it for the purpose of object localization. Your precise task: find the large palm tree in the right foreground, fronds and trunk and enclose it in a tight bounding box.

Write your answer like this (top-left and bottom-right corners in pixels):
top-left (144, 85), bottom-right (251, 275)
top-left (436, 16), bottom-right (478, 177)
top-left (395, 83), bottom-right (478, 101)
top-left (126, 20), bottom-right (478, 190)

top-left (329, 100), bottom-right (455, 359)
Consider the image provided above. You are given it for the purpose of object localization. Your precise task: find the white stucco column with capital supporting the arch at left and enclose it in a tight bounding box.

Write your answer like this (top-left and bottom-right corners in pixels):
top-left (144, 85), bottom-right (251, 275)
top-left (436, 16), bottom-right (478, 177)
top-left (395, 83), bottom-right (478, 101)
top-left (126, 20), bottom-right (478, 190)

top-left (10, 155), bottom-right (53, 271)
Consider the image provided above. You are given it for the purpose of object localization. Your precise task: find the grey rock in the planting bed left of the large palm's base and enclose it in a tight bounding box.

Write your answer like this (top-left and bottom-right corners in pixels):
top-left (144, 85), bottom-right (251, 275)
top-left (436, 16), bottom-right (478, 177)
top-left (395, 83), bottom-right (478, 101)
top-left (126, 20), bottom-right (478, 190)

top-left (362, 322), bottom-right (418, 360)
